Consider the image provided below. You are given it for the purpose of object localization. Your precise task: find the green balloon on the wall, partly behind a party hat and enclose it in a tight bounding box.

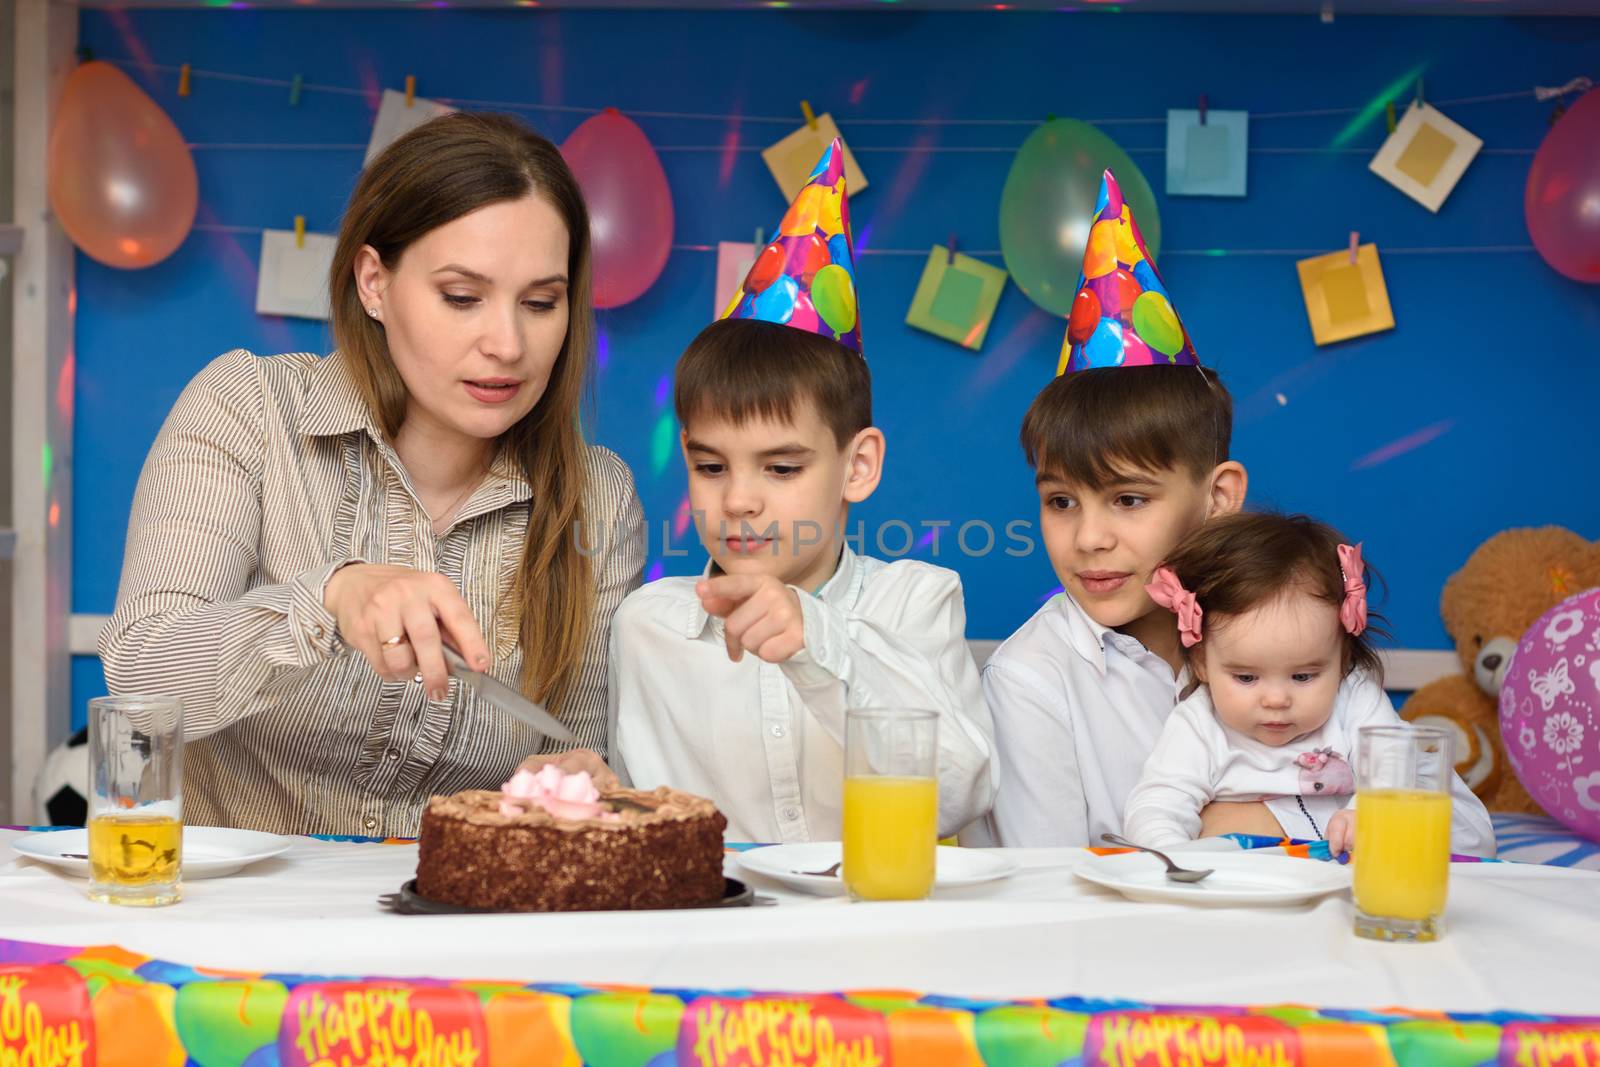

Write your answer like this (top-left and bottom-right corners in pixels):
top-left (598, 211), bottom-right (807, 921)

top-left (1000, 118), bottom-right (1162, 317)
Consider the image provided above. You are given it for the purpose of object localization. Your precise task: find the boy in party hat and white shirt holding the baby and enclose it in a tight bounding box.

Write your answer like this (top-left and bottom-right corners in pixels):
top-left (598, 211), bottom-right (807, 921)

top-left (982, 171), bottom-right (1269, 846)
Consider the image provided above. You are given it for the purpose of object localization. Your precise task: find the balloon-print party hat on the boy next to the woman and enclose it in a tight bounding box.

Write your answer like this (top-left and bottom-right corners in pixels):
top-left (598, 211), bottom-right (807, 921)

top-left (722, 138), bottom-right (861, 355)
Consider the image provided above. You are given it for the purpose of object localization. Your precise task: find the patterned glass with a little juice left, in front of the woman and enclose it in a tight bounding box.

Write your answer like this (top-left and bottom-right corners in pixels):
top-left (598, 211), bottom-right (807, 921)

top-left (88, 696), bottom-right (184, 907)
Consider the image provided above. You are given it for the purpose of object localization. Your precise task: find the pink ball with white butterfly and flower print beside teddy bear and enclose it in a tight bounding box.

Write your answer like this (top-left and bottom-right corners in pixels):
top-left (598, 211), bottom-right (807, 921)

top-left (1499, 589), bottom-right (1600, 841)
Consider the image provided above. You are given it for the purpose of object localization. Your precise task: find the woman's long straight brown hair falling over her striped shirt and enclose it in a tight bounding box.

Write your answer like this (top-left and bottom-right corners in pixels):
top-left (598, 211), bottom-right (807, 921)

top-left (328, 112), bottom-right (595, 709)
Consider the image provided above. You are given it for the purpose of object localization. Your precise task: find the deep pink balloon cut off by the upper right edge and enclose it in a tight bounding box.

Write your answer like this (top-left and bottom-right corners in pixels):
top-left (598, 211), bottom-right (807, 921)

top-left (1522, 90), bottom-right (1600, 285)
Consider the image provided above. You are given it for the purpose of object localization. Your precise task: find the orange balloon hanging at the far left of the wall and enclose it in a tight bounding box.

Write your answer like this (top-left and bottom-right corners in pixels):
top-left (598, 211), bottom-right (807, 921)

top-left (48, 62), bottom-right (200, 269)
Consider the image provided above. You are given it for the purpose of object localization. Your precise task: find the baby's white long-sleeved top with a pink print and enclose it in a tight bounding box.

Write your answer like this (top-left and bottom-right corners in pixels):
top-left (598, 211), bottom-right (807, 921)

top-left (1125, 670), bottom-right (1494, 856)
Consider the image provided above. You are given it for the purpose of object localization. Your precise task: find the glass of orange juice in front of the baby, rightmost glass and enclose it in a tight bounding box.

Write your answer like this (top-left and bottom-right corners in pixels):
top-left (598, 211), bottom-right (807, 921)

top-left (1352, 723), bottom-right (1454, 941)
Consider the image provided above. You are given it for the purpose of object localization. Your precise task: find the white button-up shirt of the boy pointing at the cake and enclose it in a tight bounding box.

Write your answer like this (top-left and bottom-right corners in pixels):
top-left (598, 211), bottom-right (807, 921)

top-left (610, 545), bottom-right (995, 841)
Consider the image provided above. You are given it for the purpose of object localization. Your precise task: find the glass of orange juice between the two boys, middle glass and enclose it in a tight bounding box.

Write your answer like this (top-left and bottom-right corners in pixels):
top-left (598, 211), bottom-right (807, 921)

top-left (842, 707), bottom-right (939, 901)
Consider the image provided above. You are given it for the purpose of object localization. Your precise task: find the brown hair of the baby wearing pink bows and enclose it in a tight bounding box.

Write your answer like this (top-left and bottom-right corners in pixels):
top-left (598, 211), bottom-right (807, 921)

top-left (1165, 512), bottom-right (1389, 683)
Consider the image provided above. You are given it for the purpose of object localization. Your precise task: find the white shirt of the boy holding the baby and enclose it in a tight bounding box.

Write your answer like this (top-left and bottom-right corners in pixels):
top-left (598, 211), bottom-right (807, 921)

top-left (962, 593), bottom-right (1189, 846)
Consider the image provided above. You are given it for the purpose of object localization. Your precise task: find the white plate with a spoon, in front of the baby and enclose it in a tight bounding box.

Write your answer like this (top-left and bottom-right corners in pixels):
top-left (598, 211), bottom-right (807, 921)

top-left (1072, 851), bottom-right (1350, 907)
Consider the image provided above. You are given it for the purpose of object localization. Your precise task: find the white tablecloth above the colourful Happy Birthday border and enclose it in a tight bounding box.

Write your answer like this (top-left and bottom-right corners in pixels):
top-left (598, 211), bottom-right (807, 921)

top-left (0, 830), bottom-right (1600, 1014)
